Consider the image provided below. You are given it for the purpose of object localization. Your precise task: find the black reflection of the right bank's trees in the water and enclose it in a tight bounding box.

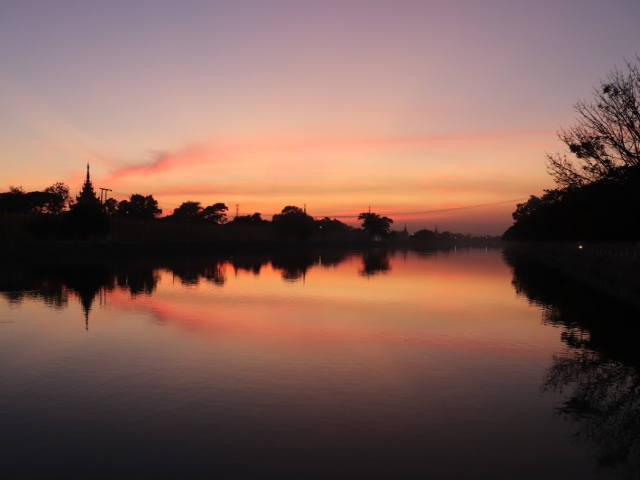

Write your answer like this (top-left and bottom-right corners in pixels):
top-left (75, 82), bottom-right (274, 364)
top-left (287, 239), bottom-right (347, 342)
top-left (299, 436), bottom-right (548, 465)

top-left (504, 250), bottom-right (640, 478)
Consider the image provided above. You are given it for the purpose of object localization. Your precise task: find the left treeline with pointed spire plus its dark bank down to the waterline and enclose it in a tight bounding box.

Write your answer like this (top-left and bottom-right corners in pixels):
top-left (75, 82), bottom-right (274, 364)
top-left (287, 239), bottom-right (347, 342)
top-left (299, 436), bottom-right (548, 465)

top-left (0, 184), bottom-right (376, 244)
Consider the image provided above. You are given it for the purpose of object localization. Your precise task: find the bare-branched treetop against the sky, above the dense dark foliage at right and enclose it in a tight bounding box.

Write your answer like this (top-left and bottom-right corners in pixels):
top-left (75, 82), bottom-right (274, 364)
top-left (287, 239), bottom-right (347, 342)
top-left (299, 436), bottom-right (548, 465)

top-left (547, 59), bottom-right (640, 187)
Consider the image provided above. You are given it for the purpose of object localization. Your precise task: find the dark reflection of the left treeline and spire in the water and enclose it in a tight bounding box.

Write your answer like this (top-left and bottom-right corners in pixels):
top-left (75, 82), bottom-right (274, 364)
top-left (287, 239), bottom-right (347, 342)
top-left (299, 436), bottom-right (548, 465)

top-left (0, 251), bottom-right (356, 326)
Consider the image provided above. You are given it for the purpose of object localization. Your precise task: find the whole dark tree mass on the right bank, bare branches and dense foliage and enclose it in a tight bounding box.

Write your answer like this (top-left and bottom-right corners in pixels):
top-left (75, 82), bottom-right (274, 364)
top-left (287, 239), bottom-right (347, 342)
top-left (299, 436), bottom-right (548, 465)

top-left (504, 59), bottom-right (640, 241)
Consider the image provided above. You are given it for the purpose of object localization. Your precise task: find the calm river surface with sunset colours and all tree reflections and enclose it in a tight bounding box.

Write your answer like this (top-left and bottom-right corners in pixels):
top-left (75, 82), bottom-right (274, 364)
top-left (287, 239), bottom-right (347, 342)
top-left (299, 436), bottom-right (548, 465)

top-left (0, 250), bottom-right (640, 479)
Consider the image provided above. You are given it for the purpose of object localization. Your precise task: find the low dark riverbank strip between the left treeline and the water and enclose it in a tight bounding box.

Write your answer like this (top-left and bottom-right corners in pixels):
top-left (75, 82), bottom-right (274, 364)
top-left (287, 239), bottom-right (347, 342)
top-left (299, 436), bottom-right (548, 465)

top-left (0, 214), bottom-right (502, 261)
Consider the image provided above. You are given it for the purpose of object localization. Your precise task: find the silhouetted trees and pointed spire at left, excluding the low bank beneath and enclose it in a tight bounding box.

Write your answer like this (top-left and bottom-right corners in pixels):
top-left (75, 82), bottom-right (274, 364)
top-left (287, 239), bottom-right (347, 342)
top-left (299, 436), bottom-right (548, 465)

top-left (0, 180), bottom-right (400, 240)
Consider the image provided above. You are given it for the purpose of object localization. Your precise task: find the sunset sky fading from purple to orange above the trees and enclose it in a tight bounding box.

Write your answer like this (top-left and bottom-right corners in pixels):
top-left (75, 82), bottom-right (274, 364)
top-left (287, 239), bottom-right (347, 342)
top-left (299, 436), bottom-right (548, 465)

top-left (0, 0), bottom-right (640, 234)
